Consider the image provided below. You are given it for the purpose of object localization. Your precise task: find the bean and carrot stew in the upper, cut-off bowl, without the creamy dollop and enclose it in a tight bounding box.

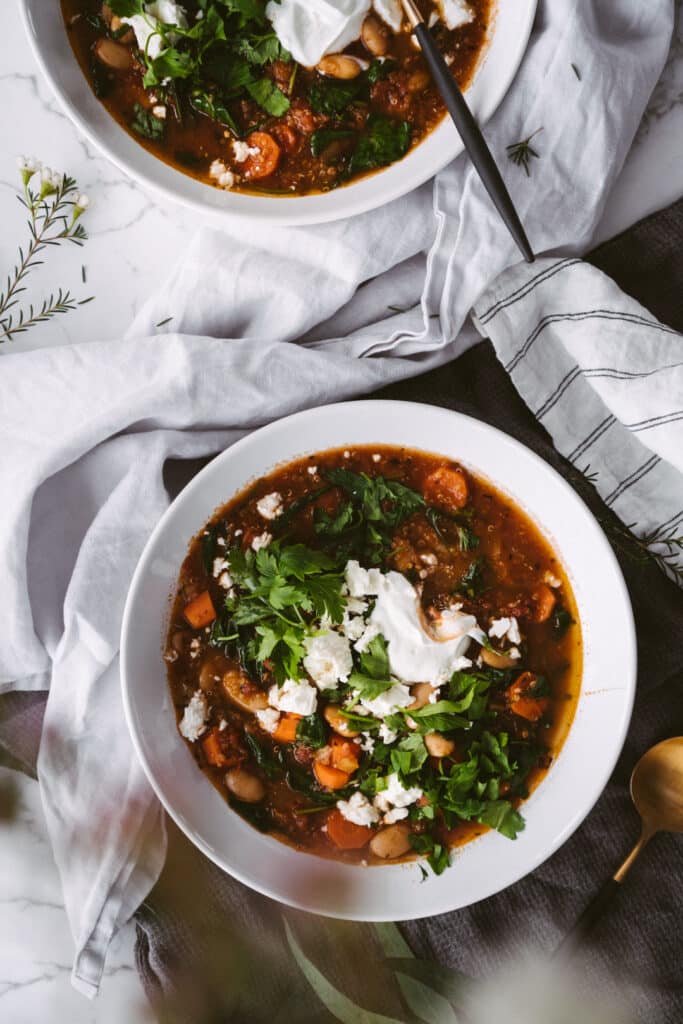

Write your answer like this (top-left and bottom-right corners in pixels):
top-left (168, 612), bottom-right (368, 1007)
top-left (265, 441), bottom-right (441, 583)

top-left (61, 0), bottom-right (492, 196)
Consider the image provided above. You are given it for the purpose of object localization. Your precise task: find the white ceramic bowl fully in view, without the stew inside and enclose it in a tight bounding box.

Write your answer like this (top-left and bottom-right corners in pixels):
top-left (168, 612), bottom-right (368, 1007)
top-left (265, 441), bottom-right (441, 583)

top-left (121, 401), bottom-right (636, 921)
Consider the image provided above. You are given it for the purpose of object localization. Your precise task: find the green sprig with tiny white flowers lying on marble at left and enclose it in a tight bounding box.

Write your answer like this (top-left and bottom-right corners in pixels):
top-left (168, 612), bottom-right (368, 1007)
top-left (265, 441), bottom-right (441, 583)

top-left (0, 158), bottom-right (92, 344)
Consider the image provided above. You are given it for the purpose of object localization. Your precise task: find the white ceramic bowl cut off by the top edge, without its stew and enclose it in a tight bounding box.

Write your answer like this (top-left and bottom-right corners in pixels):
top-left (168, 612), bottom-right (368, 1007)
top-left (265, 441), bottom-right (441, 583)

top-left (20, 0), bottom-right (537, 224)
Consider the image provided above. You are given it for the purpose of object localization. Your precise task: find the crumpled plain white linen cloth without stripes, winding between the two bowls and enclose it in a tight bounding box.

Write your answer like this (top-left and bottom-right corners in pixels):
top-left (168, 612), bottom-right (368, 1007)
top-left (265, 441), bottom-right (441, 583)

top-left (0, 0), bottom-right (673, 995)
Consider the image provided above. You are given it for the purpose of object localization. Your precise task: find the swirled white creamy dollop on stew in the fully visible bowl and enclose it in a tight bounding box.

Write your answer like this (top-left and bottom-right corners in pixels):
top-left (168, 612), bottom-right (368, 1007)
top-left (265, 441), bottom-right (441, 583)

top-left (369, 572), bottom-right (483, 686)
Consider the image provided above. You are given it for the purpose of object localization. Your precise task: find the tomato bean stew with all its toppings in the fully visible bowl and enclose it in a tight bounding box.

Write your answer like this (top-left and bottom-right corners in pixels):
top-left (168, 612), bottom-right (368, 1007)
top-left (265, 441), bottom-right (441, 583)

top-left (165, 446), bottom-right (581, 872)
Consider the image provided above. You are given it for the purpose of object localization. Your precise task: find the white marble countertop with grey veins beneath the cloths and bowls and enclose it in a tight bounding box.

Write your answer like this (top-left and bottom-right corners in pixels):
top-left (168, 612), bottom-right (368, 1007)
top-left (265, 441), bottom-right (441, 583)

top-left (0, 0), bottom-right (683, 1024)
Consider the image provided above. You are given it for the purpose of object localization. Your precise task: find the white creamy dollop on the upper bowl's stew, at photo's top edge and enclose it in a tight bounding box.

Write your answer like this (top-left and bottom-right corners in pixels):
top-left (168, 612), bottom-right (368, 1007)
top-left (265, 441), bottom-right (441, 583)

top-left (265, 0), bottom-right (401, 68)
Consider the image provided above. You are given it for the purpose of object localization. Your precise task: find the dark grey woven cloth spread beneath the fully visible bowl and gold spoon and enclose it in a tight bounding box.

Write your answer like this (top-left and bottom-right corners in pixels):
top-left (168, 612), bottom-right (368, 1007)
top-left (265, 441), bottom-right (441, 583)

top-left (0, 201), bottom-right (683, 1024)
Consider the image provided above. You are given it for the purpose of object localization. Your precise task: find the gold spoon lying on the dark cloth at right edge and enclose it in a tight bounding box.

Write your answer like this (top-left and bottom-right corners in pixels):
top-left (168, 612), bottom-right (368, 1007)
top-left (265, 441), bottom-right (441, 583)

top-left (555, 736), bottom-right (683, 955)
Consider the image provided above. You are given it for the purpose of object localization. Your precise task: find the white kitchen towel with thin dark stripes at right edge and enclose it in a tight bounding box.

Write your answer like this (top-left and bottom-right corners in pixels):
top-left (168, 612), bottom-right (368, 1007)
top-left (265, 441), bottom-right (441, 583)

top-left (474, 259), bottom-right (683, 586)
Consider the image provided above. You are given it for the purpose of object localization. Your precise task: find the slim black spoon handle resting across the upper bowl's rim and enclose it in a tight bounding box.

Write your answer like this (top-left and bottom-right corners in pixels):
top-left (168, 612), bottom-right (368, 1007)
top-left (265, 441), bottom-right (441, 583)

top-left (413, 22), bottom-right (535, 263)
